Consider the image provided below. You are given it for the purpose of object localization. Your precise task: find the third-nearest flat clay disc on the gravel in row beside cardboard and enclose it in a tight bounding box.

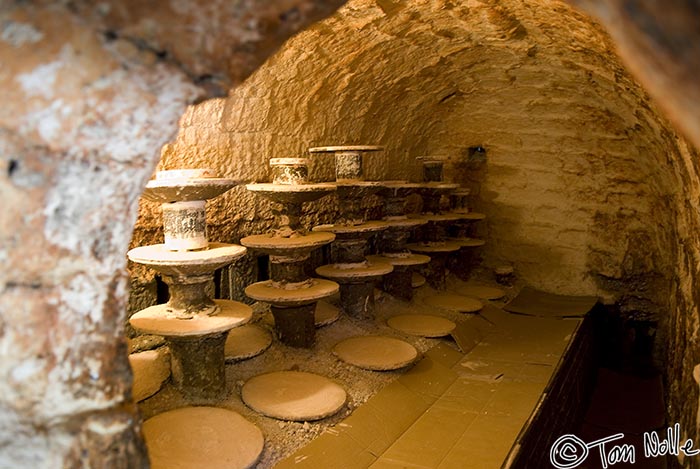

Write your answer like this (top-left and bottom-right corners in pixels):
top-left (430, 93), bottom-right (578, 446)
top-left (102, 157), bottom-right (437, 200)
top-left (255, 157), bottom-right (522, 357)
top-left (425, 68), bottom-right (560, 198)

top-left (333, 336), bottom-right (418, 371)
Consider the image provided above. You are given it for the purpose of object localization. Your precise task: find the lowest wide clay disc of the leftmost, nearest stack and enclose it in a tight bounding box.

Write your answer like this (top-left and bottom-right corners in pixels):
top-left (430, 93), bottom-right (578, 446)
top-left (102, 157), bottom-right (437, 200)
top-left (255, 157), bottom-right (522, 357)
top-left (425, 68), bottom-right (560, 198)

top-left (129, 300), bottom-right (253, 337)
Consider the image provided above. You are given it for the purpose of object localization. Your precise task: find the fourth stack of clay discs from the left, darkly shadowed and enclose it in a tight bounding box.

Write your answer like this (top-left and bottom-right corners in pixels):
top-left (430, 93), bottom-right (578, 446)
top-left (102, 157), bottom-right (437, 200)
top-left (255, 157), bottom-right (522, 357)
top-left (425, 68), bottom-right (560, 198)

top-left (368, 181), bottom-right (430, 301)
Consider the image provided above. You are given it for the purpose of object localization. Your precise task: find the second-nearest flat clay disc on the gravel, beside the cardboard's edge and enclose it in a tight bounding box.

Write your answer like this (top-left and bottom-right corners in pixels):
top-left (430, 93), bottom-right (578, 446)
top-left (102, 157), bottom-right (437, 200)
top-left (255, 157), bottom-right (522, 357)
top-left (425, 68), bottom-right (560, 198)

top-left (241, 371), bottom-right (347, 422)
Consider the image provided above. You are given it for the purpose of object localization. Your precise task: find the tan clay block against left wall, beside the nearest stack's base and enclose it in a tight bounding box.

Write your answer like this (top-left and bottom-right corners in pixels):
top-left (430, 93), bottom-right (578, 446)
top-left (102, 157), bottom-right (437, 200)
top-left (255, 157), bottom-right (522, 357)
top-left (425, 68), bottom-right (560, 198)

top-left (129, 347), bottom-right (170, 402)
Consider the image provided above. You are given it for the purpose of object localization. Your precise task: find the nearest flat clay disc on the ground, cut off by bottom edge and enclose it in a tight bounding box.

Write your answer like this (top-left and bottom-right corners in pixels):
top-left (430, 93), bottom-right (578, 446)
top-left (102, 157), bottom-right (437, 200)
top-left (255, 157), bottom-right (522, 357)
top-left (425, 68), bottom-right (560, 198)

top-left (143, 407), bottom-right (264, 469)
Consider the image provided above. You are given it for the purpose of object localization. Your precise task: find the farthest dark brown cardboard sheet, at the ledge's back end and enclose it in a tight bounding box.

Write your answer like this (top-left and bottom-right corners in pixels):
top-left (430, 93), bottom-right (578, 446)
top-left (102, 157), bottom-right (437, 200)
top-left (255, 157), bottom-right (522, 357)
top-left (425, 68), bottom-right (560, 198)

top-left (503, 287), bottom-right (598, 318)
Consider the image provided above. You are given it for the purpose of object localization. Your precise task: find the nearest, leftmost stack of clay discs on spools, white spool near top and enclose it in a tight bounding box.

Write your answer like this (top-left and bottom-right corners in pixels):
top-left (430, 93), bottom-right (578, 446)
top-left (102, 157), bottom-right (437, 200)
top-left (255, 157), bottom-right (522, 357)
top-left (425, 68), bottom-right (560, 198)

top-left (128, 170), bottom-right (252, 401)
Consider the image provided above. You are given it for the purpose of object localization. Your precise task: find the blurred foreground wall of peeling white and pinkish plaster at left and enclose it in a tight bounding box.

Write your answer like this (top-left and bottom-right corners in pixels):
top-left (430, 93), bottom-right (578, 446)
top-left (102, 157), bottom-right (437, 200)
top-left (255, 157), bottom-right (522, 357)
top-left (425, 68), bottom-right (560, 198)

top-left (0, 0), bottom-right (340, 468)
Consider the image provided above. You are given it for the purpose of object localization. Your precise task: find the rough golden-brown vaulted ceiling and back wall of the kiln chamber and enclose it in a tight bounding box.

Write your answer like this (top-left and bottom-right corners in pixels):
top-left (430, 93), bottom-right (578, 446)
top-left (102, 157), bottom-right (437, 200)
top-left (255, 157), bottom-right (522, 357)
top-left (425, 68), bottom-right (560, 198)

top-left (135, 0), bottom-right (678, 317)
